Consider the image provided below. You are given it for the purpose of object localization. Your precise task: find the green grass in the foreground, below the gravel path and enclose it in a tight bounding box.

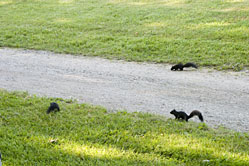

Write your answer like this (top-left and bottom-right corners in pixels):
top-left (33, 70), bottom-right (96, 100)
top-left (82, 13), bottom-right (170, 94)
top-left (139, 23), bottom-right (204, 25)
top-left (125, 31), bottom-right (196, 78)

top-left (0, 90), bottom-right (249, 166)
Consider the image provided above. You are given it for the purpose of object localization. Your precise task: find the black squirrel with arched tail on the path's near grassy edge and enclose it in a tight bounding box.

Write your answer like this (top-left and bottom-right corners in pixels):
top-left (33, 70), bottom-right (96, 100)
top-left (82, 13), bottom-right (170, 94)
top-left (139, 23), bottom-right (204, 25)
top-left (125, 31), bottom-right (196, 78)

top-left (170, 109), bottom-right (203, 122)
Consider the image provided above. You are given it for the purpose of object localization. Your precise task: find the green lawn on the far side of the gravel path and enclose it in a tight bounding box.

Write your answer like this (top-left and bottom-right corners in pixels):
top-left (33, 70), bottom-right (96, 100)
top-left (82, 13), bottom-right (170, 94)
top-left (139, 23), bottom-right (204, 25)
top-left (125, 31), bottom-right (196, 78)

top-left (0, 0), bottom-right (249, 70)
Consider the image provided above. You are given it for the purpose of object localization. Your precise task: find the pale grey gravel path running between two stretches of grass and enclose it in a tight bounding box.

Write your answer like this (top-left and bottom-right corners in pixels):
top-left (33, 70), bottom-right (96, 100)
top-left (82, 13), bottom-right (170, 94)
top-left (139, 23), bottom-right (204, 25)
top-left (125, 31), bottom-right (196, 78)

top-left (0, 48), bottom-right (249, 131)
